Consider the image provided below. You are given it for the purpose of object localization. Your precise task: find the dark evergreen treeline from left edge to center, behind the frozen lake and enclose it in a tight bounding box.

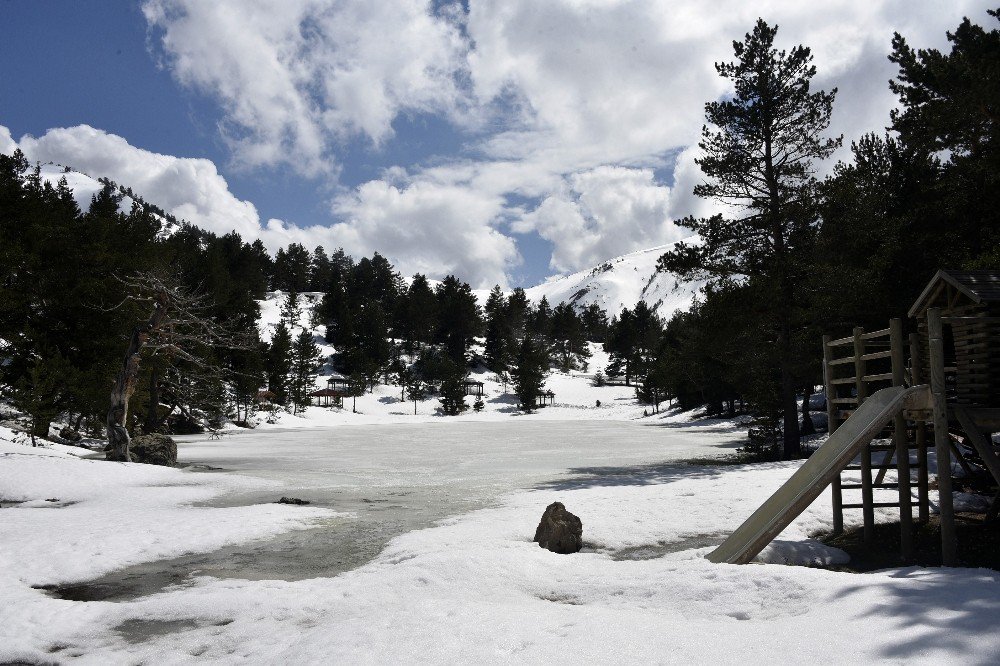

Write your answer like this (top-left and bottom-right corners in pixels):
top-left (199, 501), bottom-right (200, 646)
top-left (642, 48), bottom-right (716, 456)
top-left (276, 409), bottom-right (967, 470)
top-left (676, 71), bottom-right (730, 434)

top-left (0, 151), bottom-right (607, 437)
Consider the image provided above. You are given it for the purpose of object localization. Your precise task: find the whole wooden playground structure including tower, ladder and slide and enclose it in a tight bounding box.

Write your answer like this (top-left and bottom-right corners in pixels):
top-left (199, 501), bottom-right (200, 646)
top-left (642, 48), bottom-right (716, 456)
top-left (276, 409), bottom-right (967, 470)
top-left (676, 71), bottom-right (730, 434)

top-left (709, 271), bottom-right (1000, 566)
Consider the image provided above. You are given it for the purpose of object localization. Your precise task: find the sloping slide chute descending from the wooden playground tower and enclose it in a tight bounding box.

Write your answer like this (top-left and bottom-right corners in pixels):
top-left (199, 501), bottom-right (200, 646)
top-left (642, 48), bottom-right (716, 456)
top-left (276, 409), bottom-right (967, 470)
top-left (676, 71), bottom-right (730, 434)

top-left (708, 385), bottom-right (930, 564)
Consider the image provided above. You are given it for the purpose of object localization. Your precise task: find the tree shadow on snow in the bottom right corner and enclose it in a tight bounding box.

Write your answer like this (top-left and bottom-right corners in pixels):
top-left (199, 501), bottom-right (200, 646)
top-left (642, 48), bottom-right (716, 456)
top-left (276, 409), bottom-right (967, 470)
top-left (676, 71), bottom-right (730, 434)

top-left (838, 568), bottom-right (1000, 665)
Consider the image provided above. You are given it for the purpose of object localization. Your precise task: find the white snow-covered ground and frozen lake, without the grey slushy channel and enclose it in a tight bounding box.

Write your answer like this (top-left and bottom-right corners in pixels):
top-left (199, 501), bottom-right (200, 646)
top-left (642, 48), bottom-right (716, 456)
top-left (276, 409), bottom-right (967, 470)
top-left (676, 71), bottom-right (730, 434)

top-left (0, 417), bottom-right (1000, 664)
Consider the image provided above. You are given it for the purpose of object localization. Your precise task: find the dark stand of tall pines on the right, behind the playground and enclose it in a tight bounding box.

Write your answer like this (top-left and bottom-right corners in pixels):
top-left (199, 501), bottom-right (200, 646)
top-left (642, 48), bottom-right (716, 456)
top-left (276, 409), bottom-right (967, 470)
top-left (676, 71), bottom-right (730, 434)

top-left (654, 12), bottom-right (1000, 457)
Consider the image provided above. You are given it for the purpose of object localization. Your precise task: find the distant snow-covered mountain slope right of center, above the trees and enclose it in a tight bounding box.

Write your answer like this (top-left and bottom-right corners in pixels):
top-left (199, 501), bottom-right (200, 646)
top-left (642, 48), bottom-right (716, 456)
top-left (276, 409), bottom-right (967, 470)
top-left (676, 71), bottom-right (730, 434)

top-left (525, 240), bottom-right (702, 319)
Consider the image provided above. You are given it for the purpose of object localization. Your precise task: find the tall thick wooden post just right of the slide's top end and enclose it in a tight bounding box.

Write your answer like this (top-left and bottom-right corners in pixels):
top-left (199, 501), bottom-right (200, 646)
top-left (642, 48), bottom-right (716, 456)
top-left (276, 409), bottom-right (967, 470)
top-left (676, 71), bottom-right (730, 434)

top-left (927, 308), bottom-right (958, 567)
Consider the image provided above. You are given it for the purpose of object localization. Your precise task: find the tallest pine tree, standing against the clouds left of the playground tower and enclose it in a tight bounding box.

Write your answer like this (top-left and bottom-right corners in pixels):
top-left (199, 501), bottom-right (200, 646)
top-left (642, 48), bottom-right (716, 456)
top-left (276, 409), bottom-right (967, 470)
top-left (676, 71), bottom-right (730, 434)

top-left (658, 20), bottom-right (841, 457)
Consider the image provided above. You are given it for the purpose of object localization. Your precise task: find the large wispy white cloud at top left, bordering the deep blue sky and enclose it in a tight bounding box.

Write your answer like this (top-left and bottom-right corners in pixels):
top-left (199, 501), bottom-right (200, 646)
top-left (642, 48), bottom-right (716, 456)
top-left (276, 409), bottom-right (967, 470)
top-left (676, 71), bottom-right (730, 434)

top-left (143, 0), bottom-right (466, 175)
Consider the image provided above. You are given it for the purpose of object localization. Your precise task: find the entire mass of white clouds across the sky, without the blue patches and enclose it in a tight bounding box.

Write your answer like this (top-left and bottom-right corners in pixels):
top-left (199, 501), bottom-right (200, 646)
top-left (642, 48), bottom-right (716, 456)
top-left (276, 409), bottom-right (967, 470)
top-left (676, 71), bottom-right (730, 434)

top-left (7, 0), bottom-right (989, 286)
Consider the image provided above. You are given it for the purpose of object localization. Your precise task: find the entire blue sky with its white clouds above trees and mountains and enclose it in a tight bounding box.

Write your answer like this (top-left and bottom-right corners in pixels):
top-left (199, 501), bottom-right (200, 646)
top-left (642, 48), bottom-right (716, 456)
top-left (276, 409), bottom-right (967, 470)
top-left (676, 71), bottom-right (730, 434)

top-left (0, 0), bottom-right (989, 286)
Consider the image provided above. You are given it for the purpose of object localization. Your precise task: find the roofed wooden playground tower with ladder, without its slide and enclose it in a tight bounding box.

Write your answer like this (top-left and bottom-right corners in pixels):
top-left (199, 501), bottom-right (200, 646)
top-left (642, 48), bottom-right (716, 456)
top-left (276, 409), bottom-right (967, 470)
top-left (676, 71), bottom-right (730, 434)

top-left (823, 271), bottom-right (1000, 566)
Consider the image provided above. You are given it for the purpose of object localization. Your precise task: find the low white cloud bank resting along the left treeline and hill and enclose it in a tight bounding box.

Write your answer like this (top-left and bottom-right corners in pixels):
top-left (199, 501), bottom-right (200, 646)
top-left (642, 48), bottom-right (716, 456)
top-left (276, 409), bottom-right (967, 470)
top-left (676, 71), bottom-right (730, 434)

top-left (0, 125), bottom-right (518, 287)
